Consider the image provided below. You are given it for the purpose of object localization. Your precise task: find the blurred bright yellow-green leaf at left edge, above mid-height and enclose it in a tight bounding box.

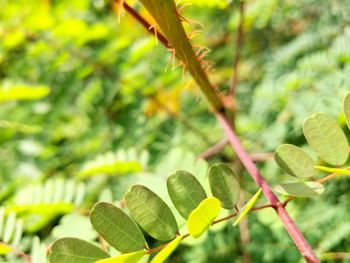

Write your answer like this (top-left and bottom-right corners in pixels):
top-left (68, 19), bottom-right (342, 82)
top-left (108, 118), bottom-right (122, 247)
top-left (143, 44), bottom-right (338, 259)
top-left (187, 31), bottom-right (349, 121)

top-left (0, 85), bottom-right (50, 102)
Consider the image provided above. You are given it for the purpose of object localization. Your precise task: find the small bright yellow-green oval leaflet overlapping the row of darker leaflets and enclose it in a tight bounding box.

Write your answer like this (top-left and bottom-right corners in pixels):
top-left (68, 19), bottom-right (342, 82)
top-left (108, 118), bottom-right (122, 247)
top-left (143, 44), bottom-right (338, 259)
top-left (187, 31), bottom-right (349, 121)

top-left (187, 197), bottom-right (221, 238)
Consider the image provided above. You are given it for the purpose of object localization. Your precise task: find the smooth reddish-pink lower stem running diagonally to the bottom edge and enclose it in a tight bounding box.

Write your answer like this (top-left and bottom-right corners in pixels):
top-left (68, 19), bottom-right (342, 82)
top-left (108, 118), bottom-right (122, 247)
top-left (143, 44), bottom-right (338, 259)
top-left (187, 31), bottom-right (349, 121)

top-left (216, 113), bottom-right (320, 263)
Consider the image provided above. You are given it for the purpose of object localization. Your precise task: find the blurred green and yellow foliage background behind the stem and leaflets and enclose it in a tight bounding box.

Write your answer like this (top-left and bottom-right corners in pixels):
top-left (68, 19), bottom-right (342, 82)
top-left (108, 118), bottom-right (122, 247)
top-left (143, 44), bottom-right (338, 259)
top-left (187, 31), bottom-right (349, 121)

top-left (0, 0), bottom-right (350, 263)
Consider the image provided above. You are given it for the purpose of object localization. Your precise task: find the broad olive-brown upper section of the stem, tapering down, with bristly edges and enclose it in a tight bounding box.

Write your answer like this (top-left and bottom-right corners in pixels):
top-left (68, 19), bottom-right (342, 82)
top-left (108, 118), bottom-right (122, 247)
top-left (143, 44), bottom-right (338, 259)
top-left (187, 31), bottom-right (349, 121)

top-left (136, 0), bottom-right (222, 110)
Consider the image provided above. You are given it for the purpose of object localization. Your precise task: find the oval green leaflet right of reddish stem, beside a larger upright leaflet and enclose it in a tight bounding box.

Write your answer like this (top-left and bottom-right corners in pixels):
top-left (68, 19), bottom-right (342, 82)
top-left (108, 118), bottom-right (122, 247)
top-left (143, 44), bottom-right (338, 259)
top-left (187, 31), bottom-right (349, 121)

top-left (274, 144), bottom-right (314, 178)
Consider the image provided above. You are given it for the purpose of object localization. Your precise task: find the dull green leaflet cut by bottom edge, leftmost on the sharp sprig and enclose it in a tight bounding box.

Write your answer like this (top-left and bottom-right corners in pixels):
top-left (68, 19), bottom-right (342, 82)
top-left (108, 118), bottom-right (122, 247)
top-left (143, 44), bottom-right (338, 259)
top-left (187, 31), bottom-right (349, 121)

top-left (49, 237), bottom-right (110, 263)
